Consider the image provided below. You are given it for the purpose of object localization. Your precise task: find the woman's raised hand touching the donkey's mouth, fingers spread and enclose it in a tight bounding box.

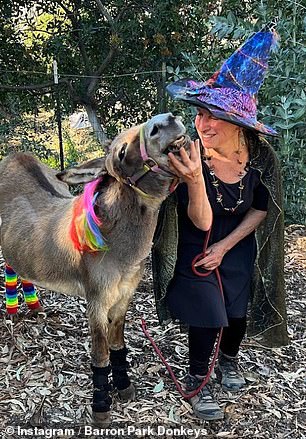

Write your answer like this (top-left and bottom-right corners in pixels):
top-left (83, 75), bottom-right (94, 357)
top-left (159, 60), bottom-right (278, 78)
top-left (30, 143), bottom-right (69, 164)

top-left (168, 140), bottom-right (202, 184)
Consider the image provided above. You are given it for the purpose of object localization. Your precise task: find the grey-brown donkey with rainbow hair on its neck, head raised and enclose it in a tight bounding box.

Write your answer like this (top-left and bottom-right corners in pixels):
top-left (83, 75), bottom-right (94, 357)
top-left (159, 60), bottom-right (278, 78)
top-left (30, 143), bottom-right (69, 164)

top-left (0, 113), bottom-right (190, 426)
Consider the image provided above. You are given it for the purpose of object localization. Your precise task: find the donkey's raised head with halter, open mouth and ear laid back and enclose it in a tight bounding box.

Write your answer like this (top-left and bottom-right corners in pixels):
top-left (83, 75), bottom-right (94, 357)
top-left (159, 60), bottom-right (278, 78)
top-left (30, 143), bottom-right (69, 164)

top-left (58, 113), bottom-right (190, 202)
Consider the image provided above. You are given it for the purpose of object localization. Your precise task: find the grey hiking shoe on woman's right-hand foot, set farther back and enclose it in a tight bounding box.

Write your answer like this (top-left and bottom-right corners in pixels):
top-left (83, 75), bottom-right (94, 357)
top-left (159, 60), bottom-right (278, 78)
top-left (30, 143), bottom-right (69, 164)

top-left (217, 352), bottom-right (246, 392)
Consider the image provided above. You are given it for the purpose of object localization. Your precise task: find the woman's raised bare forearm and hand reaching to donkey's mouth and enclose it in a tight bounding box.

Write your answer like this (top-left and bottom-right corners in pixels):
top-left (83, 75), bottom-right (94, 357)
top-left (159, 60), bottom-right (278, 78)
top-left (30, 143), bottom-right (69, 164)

top-left (168, 141), bottom-right (212, 230)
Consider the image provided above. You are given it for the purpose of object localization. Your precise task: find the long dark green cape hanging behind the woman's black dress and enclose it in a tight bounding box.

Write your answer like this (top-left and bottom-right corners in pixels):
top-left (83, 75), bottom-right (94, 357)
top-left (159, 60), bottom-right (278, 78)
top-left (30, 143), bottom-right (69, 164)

top-left (152, 133), bottom-right (288, 347)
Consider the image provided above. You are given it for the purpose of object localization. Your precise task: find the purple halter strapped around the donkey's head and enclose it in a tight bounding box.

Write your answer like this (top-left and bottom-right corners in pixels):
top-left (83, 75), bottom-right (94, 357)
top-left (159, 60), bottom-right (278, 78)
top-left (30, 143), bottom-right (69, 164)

top-left (125, 126), bottom-right (177, 198)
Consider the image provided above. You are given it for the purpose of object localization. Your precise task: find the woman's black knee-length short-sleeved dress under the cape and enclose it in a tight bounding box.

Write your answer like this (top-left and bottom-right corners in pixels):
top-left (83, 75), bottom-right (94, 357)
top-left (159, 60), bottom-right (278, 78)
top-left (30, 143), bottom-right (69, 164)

top-left (167, 163), bottom-right (269, 328)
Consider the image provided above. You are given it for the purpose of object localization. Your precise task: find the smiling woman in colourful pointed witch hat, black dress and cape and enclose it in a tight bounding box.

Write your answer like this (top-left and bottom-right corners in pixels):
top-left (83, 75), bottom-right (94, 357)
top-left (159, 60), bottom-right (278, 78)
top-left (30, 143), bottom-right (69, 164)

top-left (153, 31), bottom-right (287, 420)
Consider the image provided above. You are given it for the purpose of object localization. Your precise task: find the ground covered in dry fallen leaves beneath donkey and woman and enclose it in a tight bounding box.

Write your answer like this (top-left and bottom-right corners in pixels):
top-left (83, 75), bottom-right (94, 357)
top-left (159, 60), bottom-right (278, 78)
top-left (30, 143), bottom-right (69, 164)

top-left (0, 225), bottom-right (306, 439)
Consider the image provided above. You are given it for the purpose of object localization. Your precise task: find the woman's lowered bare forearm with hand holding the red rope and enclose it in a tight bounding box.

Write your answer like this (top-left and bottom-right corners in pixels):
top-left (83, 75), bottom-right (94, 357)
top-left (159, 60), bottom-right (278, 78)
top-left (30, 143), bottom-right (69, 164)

top-left (196, 207), bottom-right (267, 270)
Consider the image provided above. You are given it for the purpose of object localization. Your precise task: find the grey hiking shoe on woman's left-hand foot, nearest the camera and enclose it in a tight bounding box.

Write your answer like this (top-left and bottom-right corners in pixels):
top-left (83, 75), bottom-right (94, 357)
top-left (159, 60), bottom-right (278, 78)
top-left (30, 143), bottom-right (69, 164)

top-left (184, 374), bottom-right (224, 421)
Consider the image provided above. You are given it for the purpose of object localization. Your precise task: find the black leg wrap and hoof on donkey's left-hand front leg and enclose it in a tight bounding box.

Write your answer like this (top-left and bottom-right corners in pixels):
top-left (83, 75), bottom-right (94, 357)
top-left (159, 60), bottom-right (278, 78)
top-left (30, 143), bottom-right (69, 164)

top-left (91, 365), bottom-right (112, 427)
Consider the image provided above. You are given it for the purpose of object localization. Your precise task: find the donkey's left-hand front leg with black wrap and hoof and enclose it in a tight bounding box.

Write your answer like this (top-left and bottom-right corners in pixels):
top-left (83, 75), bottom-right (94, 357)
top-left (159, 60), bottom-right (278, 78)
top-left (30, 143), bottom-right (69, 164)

top-left (89, 303), bottom-right (112, 427)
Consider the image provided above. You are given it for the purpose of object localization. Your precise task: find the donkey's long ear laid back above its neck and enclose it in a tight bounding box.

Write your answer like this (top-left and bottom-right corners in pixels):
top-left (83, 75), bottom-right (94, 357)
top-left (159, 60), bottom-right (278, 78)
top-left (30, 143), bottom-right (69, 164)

top-left (56, 157), bottom-right (107, 186)
